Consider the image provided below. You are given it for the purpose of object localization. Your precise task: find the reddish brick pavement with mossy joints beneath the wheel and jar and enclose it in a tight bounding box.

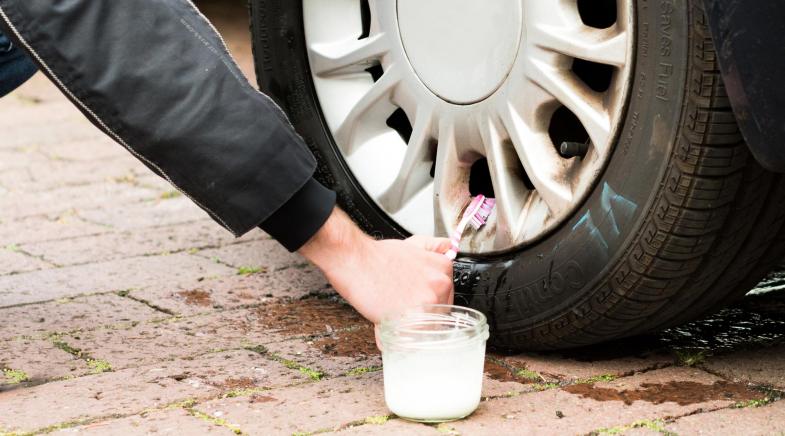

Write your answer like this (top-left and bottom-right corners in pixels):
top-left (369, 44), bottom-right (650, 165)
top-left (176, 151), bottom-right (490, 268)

top-left (0, 4), bottom-right (785, 435)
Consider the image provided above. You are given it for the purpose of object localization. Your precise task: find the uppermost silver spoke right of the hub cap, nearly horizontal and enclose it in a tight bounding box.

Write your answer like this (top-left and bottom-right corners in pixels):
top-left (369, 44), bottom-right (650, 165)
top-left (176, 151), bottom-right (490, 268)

top-left (530, 24), bottom-right (628, 68)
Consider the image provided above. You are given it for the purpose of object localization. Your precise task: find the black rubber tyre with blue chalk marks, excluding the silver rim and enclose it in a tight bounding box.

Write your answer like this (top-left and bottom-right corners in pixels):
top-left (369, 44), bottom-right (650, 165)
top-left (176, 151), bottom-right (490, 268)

top-left (250, 0), bottom-right (785, 349)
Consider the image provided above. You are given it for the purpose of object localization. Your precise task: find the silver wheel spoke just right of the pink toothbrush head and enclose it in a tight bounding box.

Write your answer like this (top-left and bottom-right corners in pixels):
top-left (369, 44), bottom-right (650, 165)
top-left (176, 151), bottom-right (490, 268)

top-left (480, 120), bottom-right (529, 248)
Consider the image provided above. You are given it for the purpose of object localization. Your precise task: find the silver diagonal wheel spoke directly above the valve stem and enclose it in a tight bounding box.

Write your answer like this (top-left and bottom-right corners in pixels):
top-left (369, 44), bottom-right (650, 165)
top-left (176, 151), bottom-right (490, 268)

top-left (529, 59), bottom-right (611, 155)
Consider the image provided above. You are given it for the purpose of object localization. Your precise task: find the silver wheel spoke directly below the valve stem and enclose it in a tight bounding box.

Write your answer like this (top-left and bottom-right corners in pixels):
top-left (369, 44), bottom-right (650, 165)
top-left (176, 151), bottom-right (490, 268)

top-left (503, 104), bottom-right (573, 215)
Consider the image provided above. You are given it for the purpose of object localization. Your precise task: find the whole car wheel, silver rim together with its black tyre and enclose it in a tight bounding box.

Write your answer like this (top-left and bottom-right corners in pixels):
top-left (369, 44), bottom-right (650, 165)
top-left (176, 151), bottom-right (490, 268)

top-left (250, 0), bottom-right (785, 349)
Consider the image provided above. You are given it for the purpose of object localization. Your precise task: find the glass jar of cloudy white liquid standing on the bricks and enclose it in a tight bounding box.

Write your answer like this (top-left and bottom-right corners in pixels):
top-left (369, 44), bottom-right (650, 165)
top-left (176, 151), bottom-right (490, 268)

top-left (380, 305), bottom-right (488, 422)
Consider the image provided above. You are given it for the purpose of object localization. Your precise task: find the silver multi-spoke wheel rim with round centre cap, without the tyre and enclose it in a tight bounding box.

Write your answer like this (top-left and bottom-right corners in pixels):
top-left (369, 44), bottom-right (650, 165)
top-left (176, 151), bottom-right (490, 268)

top-left (303, 0), bottom-right (634, 253)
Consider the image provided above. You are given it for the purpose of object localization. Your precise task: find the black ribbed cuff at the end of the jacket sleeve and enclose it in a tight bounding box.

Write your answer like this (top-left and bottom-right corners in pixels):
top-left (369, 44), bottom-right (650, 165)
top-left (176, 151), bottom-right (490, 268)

top-left (259, 178), bottom-right (336, 252)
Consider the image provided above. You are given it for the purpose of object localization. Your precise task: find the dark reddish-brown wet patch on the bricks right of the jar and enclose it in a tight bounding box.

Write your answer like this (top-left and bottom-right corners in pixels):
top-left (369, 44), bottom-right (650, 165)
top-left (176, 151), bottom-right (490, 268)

top-left (563, 381), bottom-right (765, 406)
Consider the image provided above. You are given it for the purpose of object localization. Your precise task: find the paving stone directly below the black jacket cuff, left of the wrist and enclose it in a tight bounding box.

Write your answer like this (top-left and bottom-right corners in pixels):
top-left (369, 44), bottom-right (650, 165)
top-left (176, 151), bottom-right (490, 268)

top-left (197, 239), bottom-right (308, 271)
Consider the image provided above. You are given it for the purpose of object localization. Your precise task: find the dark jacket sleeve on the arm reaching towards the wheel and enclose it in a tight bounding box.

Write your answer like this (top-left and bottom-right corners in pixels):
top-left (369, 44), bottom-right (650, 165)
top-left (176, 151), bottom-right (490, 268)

top-left (0, 0), bottom-right (335, 249)
